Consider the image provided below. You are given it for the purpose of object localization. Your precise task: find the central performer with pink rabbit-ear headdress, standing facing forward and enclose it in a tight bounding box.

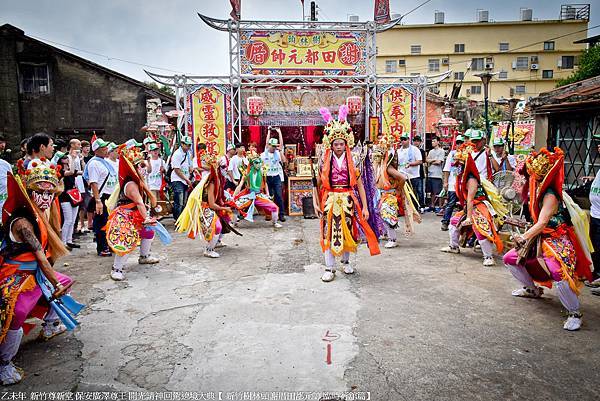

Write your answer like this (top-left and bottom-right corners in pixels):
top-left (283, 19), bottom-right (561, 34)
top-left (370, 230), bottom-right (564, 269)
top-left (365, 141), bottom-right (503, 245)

top-left (313, 105), bottom-right (380, 282)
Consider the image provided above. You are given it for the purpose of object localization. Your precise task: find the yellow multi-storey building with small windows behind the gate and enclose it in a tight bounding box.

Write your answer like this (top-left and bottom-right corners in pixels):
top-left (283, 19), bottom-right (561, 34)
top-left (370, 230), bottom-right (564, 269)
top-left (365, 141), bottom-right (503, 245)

top-left (377, 5), bottom-right (590, 101)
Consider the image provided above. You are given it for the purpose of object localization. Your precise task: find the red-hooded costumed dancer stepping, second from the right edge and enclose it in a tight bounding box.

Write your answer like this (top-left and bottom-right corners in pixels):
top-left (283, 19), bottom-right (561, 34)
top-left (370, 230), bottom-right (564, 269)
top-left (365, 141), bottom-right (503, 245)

top-left (441, 143), bottom-right (508, 267)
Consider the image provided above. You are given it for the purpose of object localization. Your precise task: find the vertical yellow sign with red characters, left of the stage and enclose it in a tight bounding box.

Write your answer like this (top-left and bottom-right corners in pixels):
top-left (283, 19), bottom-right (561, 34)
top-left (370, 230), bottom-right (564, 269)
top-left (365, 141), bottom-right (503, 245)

top-left (191, 87), bottom-right (228, 156)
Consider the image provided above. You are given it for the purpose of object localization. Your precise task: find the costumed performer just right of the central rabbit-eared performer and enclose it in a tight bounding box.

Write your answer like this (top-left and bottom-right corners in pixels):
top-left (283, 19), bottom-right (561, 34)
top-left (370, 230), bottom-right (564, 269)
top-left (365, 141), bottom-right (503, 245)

top-left (373, 130), bottom-right (421, 248)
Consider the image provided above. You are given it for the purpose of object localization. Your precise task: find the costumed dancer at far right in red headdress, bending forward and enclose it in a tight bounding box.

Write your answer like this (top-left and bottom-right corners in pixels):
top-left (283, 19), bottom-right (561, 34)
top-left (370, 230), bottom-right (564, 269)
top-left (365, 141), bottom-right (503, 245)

top-left (504, 148), bottom-right (592, 331)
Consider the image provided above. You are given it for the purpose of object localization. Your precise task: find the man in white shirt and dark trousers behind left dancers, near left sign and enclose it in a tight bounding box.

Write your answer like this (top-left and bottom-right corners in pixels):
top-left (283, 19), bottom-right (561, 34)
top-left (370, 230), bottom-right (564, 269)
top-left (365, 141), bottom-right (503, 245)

top-left (171, 136), bottom-right (192, 221)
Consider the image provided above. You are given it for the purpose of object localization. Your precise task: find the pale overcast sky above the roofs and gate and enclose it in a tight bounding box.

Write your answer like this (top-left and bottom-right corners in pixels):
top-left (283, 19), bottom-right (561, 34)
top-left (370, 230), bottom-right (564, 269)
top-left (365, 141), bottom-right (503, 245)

top-left (0, 0), bottom-right (600, 80)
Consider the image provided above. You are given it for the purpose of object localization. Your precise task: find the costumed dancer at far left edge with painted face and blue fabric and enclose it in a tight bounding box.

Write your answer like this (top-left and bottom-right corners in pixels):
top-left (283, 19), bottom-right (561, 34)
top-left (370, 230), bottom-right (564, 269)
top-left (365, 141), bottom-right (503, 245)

top-left (0, 161), bottom-right (84, 385)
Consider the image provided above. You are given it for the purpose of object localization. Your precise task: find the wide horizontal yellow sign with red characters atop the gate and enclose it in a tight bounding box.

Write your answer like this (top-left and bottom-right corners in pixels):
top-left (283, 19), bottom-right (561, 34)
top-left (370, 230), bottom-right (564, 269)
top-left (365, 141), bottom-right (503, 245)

top-left (241, 31), bottom-right (366, 75)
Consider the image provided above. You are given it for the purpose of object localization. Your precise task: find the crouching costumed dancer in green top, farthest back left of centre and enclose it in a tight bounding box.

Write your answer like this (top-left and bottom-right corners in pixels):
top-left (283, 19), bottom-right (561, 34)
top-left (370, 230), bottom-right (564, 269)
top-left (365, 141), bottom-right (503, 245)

top-left (226, 151), bottom-right (282, 228)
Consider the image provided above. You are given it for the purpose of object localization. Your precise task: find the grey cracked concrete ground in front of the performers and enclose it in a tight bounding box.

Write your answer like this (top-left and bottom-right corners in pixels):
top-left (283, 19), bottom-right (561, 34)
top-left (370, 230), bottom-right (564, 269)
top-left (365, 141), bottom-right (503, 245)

top-left (4, 215), bottom-right (600, 401)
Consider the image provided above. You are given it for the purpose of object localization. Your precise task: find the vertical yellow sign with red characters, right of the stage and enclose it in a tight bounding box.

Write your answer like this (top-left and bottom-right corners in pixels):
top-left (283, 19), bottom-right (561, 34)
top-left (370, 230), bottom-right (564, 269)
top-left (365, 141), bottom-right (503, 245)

top-left (381, 87), bottom-right (412, 136)
